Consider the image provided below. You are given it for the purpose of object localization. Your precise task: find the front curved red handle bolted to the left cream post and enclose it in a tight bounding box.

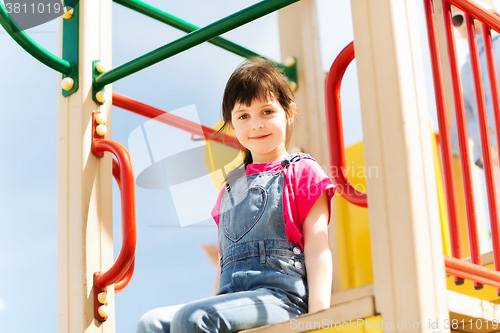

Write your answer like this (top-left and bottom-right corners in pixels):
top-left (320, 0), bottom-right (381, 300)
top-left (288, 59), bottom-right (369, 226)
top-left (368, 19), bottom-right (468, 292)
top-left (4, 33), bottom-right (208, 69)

top-left (94, 140), bottom-right (137, 289)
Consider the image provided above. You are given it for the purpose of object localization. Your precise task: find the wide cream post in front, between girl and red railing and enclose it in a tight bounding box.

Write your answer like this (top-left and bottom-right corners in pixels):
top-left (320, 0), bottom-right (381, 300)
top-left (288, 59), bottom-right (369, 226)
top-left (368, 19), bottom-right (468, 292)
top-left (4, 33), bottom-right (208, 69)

top-left (351, 0), bottom-right (449, 332)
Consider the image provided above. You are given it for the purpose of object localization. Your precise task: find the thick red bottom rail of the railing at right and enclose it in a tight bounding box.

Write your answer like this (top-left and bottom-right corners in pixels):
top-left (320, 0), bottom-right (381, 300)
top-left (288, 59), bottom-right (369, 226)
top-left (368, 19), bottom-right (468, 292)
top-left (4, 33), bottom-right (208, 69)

top-left (444, 256), bottom-right (500, 288)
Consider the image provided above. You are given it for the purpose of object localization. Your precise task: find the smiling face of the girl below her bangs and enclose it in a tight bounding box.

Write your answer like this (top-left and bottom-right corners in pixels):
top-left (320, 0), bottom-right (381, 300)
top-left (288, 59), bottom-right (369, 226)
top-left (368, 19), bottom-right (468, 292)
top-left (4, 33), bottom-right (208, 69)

top-left (231, 99), bottom-right (295, 163)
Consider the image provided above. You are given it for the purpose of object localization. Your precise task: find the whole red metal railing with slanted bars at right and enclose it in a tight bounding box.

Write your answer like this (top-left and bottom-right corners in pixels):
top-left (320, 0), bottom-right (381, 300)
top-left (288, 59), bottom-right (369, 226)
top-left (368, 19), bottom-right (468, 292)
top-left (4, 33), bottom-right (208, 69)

top-left (424, 0), bottom-right (500, 292)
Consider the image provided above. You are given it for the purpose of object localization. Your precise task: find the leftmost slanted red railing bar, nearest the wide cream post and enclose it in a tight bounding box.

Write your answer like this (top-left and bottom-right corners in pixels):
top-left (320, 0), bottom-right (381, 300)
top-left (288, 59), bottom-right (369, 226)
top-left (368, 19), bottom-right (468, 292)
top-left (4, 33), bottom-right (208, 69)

top-left (424, 0), bottom-right (463, 268)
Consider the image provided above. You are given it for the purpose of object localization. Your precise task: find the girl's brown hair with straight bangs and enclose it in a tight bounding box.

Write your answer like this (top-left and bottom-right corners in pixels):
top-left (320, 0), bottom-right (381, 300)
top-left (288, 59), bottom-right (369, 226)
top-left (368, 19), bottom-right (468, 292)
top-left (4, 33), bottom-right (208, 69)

top-left (218, 58), bottom-right (295, 168)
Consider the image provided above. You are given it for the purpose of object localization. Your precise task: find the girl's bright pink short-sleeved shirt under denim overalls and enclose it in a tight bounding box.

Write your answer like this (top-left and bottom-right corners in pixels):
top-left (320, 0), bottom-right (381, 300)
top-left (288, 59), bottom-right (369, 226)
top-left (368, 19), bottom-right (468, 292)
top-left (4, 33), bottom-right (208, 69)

top-left (212, 158), bottom-right (335, 248)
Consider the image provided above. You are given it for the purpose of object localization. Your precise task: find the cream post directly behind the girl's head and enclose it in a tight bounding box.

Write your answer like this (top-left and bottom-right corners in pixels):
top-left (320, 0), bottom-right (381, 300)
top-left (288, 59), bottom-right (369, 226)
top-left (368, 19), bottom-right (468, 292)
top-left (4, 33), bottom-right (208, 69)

top-left (278, 0), bottom-right (329, 166)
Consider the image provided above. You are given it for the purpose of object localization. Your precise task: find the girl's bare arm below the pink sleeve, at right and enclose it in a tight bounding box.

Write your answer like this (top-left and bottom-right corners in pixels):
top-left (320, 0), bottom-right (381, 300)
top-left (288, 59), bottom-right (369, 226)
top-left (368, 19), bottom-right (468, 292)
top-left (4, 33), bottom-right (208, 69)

top-left (302, 191), bottom-right (332, 313)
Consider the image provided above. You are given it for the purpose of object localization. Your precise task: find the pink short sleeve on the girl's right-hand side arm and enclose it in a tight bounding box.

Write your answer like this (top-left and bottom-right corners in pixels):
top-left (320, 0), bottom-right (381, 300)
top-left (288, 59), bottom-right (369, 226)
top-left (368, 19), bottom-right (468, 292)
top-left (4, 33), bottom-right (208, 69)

top-left (293, 159), bottom-right (335, 225)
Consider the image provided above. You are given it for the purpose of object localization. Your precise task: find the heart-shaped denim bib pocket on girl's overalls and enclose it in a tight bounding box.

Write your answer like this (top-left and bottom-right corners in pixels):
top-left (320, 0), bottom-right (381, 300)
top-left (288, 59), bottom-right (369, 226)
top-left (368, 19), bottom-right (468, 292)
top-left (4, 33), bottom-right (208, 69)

top-left (221, 186), bottom-right (267, 242)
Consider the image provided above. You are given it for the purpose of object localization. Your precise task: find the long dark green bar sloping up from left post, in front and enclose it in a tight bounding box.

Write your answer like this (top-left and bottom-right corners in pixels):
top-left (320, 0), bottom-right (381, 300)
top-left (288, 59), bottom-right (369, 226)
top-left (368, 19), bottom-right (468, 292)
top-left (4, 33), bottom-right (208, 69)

top-left (94, 0), bottom-right (299, 89)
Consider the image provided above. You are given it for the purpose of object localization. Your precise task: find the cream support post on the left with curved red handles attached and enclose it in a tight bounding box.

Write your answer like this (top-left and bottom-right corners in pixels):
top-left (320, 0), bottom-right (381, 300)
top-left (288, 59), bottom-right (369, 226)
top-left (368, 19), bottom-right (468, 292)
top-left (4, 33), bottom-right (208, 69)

top-left (57, 0), bottom-right (115, 333)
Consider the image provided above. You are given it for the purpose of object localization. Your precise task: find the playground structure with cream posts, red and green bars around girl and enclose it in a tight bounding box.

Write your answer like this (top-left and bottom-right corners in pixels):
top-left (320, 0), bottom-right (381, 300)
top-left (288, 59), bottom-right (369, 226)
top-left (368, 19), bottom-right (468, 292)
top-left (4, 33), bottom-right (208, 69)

top-left (4, 0), bottom-right (500, 332)
